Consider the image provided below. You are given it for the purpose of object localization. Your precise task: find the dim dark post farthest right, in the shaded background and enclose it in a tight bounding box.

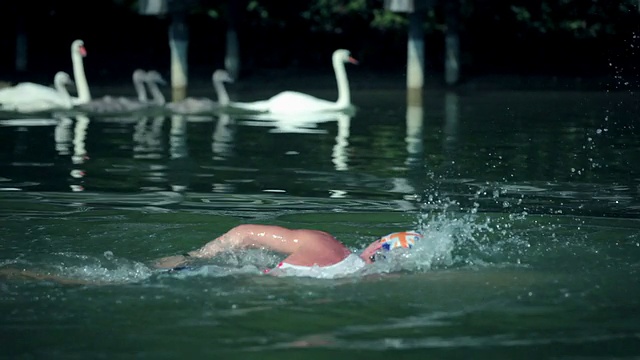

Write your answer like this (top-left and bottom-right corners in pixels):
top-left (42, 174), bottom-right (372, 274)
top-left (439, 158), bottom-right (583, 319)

top-left (444, 0), bottom-right (460, 85)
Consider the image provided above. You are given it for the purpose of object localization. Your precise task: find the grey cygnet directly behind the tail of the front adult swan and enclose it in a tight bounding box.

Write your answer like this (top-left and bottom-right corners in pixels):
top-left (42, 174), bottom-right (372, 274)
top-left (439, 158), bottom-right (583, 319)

top-left (166, 69), bottom-right (233, 115)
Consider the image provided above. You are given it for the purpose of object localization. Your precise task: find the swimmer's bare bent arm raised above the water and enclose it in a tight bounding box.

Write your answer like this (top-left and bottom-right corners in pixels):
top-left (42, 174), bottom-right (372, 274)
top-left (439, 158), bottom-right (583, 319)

top-left (187, 224), bottom-right (306, 258)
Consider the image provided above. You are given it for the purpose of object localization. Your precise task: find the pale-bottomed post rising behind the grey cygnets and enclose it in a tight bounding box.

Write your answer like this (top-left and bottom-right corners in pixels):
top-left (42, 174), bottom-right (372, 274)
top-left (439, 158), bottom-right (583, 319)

top-left (169, 12), bottom-right (189, 101)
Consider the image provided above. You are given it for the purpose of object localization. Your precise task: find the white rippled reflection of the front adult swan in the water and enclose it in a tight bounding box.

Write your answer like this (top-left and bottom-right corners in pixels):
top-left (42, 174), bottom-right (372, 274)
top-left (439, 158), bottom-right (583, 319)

top-left (241, 112), bottom-right (351, 171)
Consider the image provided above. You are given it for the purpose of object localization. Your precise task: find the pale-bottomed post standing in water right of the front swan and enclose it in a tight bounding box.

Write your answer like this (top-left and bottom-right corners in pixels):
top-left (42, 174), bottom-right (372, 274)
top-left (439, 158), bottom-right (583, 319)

top-left (407, 11), bottom-right (424, 104)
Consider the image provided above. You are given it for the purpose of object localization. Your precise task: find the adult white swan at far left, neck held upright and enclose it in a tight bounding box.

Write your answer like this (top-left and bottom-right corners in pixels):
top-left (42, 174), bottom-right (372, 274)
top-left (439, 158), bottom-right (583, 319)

top-left (0, 40), bottom-right (91, 112)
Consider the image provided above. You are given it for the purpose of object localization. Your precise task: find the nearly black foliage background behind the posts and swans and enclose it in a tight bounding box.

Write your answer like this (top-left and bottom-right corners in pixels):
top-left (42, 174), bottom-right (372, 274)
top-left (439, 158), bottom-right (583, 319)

top-left (0, 0), bottom-right (640, 83)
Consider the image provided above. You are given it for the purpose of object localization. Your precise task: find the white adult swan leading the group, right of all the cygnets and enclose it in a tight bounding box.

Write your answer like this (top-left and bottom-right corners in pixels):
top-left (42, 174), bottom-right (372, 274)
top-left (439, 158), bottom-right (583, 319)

top-left (229, 49), bottom-right (358, 114)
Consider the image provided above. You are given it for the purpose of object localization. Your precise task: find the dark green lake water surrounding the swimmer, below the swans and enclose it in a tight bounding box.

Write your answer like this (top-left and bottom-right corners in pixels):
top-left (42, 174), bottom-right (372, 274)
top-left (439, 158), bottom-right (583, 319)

top-left (0, 89), bottom-right (640, 359)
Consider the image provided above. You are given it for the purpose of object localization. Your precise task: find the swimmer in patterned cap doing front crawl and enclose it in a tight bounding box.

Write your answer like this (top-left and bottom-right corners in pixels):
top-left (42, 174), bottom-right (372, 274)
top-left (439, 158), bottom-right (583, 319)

top-left (154, 224), bottom-right (422, 278)
